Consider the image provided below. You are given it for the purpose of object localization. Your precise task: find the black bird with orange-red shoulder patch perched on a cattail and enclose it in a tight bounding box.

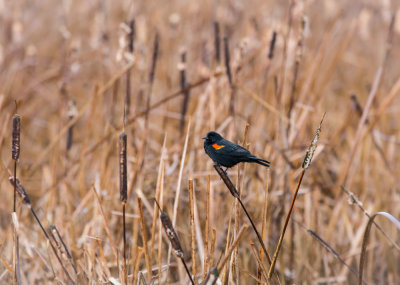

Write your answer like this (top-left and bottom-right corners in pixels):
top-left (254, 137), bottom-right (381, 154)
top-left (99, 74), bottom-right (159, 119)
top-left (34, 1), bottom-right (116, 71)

top-left (203, 132), bottom-right (270, 168)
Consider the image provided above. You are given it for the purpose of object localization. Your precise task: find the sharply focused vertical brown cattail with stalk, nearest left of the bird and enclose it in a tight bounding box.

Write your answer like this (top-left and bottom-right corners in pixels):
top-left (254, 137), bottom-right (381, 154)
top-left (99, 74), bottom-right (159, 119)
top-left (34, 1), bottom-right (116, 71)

top-left (119, 132), bottom-right (128, 284)
